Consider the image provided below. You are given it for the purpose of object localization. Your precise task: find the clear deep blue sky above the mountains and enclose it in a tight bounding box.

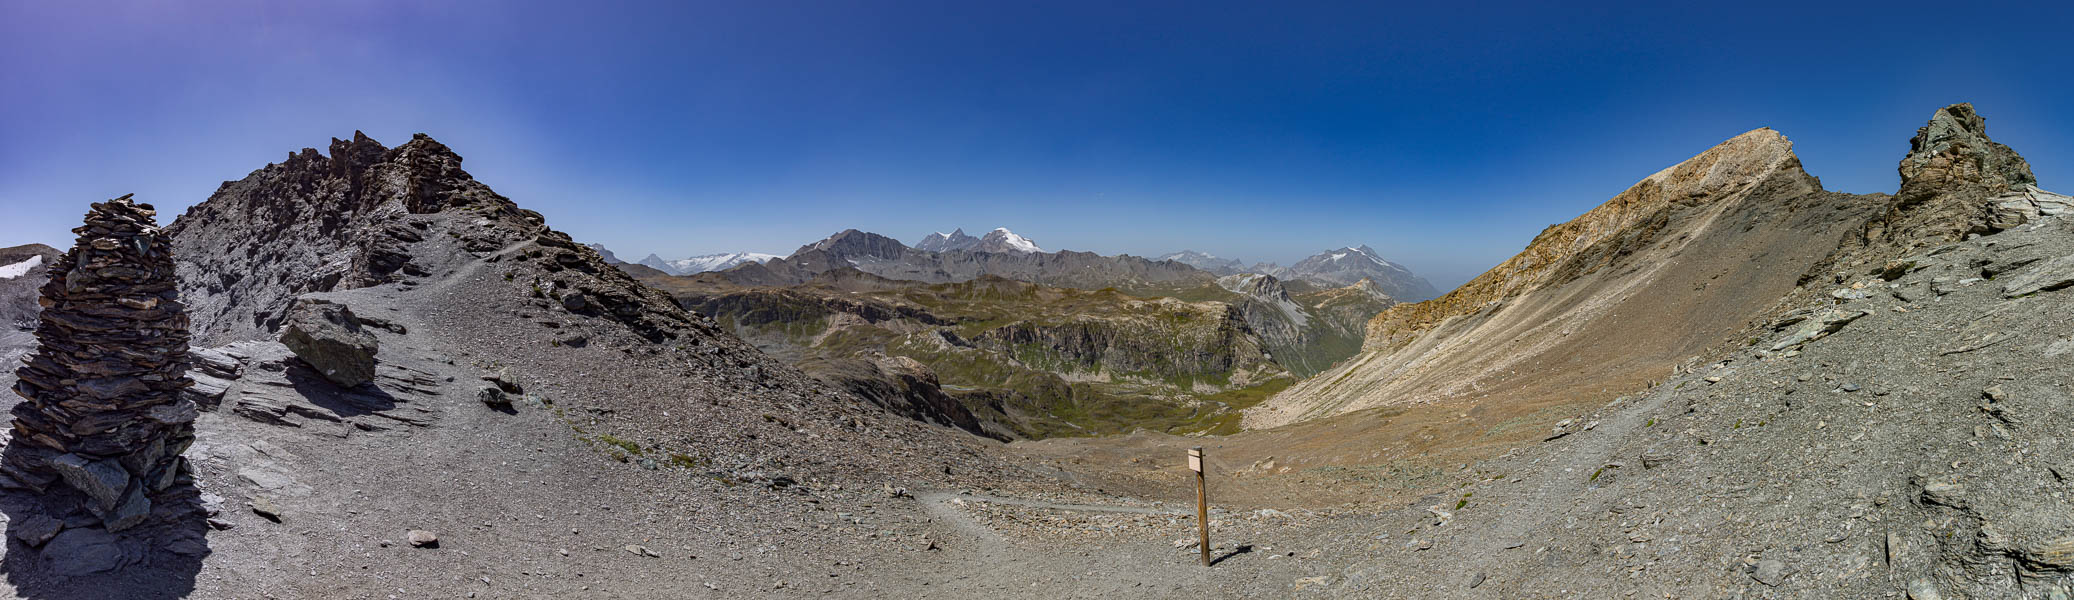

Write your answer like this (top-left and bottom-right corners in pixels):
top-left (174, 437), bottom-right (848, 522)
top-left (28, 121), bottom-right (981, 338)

top-left (0, 0), bottom-right (2074, 287)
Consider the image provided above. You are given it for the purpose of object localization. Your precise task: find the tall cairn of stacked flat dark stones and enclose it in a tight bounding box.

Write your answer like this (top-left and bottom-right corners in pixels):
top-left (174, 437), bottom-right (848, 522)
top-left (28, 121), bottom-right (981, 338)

top-left (0, 195), bottom-right (197, 531)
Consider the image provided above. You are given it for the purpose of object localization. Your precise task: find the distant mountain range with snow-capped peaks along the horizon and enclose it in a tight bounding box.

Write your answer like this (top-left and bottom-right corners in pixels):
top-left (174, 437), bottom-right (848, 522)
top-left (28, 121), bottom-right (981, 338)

top-left (630, 228), bottom-right (1435, 376)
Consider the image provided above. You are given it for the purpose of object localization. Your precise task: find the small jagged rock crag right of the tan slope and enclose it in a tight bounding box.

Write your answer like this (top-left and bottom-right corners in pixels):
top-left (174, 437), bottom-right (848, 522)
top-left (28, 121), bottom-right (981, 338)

top-left (1898, 104), bottom-right (2039, 201)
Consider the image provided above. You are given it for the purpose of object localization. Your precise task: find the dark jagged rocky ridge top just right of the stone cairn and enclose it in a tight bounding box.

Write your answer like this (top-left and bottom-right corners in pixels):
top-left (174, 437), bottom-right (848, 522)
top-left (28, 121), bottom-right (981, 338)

top-left (166, 133), bottom-right (713, 345)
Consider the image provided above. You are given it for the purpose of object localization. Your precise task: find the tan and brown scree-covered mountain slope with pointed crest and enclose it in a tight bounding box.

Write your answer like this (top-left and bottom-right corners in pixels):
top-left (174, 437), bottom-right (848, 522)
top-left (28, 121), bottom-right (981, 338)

top-left (1246, 129), bottom-right (1885, 428)
